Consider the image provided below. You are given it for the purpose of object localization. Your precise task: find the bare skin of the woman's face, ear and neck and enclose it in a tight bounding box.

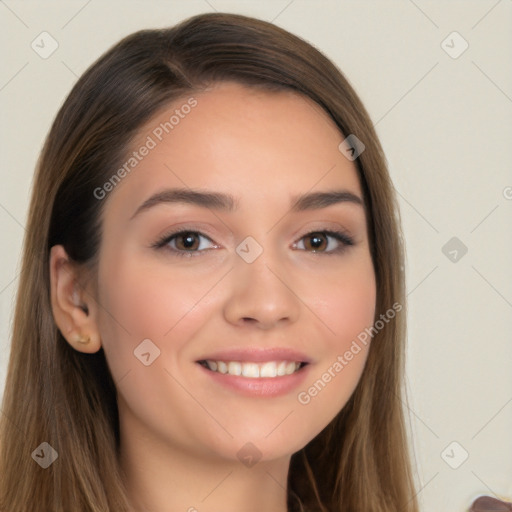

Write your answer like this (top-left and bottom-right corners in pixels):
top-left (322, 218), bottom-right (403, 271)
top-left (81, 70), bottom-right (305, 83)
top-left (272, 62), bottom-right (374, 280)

top-left (51, 83), bottom-right (376, 512)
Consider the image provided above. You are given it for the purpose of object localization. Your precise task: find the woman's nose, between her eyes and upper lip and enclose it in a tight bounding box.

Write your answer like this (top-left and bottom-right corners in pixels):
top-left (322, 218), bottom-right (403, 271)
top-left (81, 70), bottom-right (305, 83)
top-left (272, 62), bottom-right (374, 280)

top-left (224, 246), bottom-right (301, 330)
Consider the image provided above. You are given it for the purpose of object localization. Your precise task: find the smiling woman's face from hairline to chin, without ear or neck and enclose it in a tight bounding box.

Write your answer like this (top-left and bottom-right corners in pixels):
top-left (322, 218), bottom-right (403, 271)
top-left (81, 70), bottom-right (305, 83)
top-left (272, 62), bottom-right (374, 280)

top-left (93, 83), bottom-right (376, 463)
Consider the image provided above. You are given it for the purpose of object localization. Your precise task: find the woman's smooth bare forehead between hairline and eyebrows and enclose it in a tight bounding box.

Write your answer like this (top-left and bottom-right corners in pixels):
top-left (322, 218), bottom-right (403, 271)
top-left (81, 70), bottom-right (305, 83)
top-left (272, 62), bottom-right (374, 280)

top-left (104, 82), bottom-right (361, 213)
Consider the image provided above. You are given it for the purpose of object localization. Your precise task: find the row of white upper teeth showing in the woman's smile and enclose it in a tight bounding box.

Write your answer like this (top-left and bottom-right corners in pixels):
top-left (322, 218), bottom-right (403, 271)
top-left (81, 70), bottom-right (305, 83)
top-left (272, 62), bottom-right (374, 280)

top-left (198, 359), bottom-right (308, 379)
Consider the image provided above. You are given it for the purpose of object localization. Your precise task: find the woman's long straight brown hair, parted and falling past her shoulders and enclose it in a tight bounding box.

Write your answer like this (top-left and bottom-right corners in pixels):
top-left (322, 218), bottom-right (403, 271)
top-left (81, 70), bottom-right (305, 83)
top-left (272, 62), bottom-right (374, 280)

top-left (0, 13), bottom-right (418, 512)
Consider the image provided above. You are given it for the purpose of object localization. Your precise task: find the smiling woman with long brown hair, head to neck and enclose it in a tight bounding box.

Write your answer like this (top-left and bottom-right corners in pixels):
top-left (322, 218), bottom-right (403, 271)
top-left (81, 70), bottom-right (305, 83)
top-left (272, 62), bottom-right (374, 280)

top-left (0, 14), bottom-right (418, 512)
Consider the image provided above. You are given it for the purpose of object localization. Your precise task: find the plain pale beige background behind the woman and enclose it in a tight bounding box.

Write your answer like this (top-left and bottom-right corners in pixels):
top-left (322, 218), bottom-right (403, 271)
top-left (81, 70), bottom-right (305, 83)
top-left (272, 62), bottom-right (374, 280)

top-left (0, 0), bottom-right (512, 512)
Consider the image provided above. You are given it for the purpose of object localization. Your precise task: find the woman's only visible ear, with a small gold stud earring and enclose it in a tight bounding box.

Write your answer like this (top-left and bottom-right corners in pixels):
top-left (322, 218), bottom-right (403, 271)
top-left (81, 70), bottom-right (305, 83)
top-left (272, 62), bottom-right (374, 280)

top-left (50, 245), bottom-right (101, 354)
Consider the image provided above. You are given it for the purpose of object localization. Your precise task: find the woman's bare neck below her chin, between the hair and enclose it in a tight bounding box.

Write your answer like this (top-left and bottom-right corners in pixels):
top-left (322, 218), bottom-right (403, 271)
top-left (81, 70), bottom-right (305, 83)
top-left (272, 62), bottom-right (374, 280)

top-left (120, 412), bottom-right (290, 512)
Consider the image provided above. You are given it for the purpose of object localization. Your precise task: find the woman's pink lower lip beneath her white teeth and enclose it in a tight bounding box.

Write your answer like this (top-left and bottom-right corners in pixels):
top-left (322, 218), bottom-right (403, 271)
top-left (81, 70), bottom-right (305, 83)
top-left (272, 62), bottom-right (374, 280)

top-left (197, 363), bottom-right (310, 397)
